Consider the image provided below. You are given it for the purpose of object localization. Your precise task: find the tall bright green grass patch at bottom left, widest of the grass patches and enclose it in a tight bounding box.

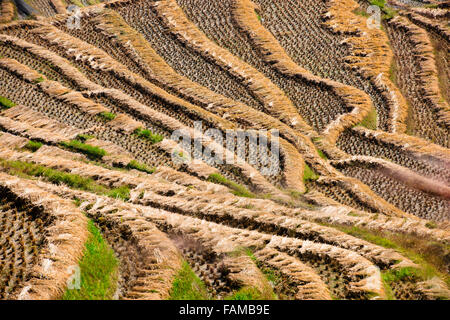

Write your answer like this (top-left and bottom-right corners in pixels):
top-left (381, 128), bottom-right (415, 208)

top-left (63, 220), bottom-right (119, 300)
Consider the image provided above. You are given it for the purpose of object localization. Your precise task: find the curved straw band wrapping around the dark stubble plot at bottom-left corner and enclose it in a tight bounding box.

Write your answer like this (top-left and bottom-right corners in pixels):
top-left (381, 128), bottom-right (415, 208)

top-left (0, 173), bottom-right (88, 300)
